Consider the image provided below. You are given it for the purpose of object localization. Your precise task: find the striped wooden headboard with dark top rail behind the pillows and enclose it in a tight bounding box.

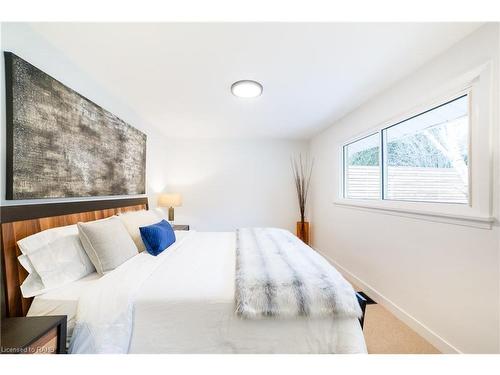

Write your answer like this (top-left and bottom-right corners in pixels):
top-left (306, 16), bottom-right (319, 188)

top-left (0, 197), bottom-right (148, 317)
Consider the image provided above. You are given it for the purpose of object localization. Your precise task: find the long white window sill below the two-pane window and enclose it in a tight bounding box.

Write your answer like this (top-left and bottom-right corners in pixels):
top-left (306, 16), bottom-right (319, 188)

top-left (333, 199), bottom-right (495, 229)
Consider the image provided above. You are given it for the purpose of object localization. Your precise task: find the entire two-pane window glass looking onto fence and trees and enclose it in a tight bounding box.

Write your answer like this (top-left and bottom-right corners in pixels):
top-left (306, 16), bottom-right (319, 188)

top-left (343, 94), bottom-right (469, 204)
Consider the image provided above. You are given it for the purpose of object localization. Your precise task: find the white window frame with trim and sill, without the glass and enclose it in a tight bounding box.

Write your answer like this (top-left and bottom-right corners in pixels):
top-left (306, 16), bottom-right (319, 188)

top-left (334, 63), bottom-right (495, 229)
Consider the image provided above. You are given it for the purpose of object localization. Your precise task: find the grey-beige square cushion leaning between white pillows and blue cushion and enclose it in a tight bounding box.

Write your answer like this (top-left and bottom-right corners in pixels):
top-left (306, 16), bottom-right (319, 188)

top-left (77, 216), bottom-right (138, 275)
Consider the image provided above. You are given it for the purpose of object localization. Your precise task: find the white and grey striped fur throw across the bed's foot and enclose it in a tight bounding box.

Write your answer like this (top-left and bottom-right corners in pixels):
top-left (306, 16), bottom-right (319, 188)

top-left (235, 228), bottom-right (362, 319)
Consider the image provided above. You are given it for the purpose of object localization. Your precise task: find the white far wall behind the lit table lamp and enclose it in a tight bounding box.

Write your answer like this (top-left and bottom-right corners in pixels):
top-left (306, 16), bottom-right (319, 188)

top-left (149, 139), bottom-right (306, 231)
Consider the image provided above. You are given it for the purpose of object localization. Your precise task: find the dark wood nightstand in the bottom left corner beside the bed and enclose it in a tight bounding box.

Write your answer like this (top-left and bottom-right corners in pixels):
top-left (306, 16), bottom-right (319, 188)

top-left (0, 315), bottom-right (66, 354)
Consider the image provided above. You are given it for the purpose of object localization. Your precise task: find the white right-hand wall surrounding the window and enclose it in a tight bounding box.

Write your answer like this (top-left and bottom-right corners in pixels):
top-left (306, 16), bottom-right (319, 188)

top-left (311, 24), bottom-right (500, 353)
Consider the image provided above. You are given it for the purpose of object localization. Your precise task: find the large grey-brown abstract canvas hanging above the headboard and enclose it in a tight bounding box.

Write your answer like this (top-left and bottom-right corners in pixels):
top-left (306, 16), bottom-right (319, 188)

top-left (5, 52), bottom-right (146, 199)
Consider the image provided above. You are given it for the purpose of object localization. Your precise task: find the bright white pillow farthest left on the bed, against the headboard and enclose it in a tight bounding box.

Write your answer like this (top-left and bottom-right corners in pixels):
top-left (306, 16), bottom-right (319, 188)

top-left (17, 225), bottom-right (95, 297)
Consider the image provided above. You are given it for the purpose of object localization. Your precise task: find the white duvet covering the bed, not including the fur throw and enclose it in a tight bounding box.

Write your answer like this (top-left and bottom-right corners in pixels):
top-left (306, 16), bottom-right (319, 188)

top-left (64, 232), bottom-right (366, 353)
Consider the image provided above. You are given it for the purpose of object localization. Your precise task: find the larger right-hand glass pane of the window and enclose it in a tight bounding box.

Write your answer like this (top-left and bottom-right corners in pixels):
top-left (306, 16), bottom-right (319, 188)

top-left (383, 96), bottom-right (469, 203)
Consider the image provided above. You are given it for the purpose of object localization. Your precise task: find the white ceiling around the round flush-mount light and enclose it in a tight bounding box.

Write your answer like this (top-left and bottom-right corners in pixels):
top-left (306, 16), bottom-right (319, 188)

top-left (27, 23), bottom-right (480, 139)
